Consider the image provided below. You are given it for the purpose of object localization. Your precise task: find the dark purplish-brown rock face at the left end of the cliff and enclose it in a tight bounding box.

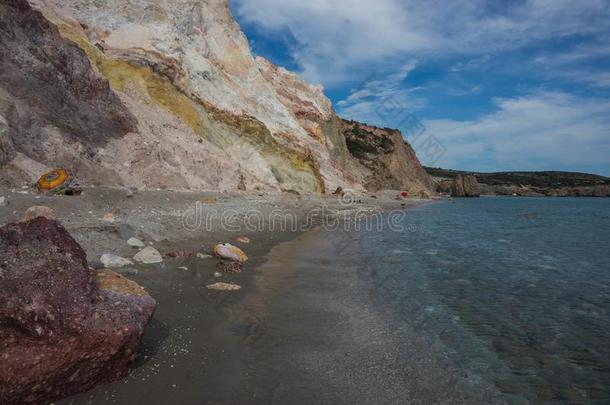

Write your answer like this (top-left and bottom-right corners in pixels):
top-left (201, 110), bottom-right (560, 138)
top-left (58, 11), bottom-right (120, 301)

top-left (0, 0), bottom-right (136, 185)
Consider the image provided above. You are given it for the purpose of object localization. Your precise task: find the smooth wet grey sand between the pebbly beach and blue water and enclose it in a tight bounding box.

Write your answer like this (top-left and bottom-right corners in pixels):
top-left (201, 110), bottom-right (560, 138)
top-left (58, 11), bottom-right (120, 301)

top-left (233, 230), bottom-right (502, 404)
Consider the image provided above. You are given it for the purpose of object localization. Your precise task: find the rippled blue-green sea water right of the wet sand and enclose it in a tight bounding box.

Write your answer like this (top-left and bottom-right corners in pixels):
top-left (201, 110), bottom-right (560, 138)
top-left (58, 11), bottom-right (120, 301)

top-left (358, 198), bottom-right (610, 403)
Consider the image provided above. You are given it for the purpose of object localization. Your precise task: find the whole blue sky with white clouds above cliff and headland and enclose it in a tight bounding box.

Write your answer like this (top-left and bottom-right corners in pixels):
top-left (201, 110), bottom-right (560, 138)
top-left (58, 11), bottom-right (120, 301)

top-left (231, 0), bottom-right (610, 176)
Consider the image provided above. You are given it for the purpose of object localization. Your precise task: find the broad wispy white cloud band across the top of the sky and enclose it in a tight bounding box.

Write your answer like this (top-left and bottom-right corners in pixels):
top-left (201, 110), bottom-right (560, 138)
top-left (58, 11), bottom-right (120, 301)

top-left (233, 0), bottom-right (610, 85)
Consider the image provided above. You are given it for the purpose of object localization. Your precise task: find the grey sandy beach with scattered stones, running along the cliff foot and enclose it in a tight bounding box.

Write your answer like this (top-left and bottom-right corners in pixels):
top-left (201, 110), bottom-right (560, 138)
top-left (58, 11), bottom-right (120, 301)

top-left (0, 188), bottom-right (436, 404)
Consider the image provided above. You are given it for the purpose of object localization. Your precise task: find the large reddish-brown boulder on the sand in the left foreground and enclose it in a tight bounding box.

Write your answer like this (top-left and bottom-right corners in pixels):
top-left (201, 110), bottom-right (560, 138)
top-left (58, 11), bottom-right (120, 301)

top-left (0, 217), bottom-right (156, 404)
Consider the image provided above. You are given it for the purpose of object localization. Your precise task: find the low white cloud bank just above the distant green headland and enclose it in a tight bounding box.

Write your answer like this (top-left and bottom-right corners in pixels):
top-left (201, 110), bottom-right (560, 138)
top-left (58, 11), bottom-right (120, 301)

top-left (424, 92), bottom-right (610, 174)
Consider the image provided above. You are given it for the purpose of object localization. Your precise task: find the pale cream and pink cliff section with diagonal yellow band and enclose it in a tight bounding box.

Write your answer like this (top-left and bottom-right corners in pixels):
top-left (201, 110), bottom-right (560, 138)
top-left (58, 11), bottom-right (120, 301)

top-left (0, 0), bottom-right (434, 193)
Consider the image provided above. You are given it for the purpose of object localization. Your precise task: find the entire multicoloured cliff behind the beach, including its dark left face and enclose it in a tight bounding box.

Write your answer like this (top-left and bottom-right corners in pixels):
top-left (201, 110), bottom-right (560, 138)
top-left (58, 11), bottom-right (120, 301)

top-left (0, 0), bottom-right (433, 196)
